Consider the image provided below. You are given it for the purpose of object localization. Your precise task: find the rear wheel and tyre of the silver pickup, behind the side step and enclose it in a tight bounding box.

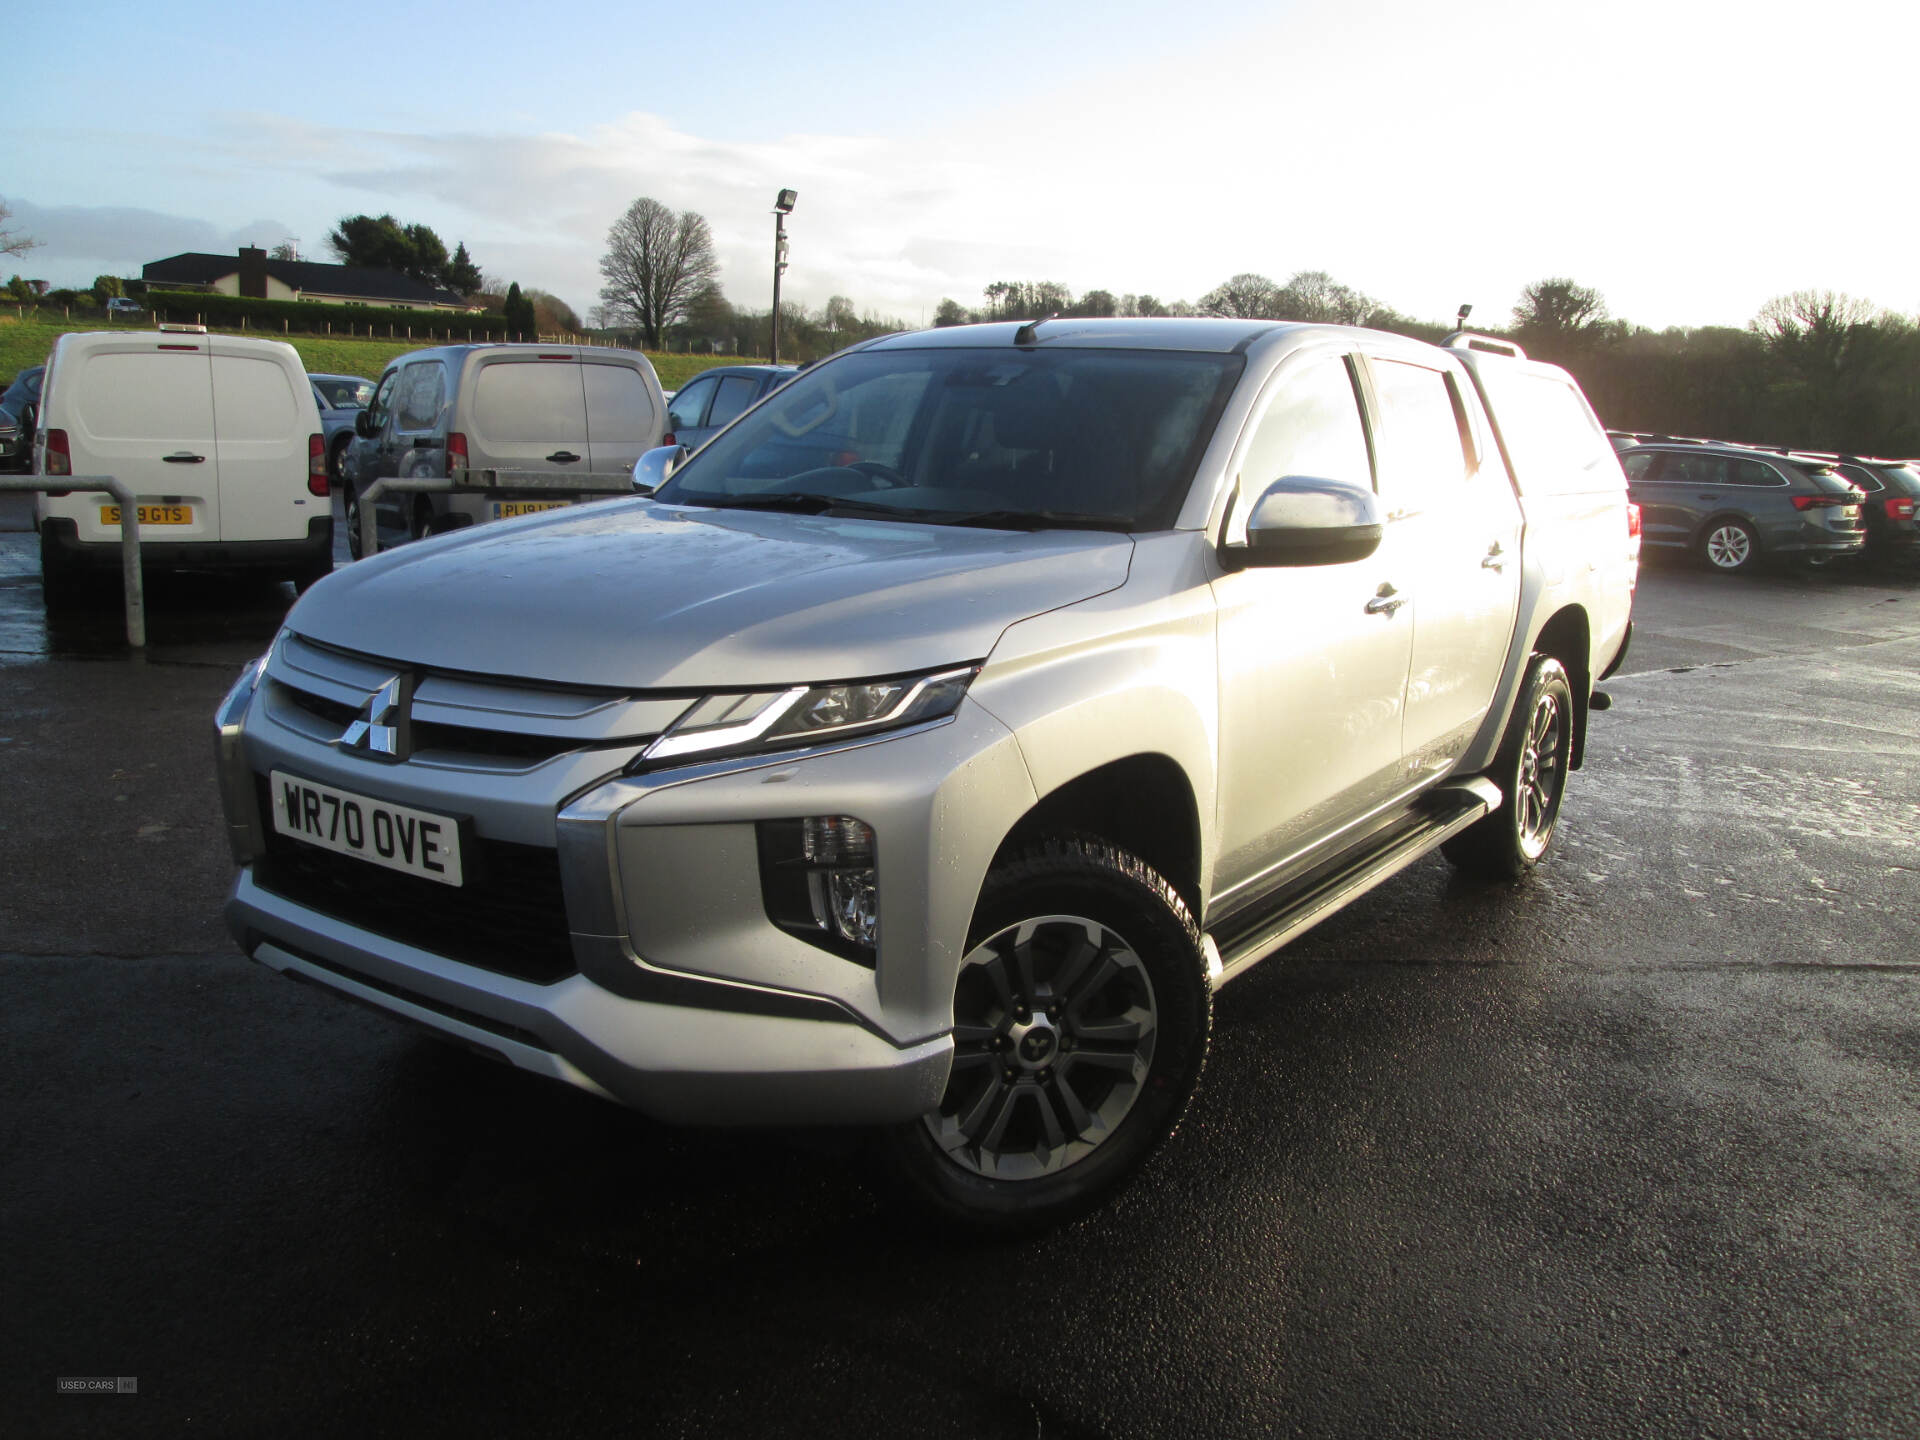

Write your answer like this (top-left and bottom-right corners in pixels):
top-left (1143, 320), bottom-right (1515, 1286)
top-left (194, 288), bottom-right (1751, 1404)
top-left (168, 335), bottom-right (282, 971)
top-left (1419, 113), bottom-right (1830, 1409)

top-left (1440, 655), bottom-right (1574, 879)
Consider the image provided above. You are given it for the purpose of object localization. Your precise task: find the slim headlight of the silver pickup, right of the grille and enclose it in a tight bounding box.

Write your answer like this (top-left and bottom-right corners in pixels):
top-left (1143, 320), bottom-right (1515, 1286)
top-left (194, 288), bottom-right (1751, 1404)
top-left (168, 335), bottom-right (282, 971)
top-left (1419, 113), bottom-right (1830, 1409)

top-left (634, 664), bottom-right (979, 768)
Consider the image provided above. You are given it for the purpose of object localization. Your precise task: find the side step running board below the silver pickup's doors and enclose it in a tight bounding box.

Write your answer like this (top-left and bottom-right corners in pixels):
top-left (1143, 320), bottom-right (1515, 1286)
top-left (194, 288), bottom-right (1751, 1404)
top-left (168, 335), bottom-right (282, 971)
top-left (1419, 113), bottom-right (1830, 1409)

top-left (1208, 776), bottom-right (1501, 989)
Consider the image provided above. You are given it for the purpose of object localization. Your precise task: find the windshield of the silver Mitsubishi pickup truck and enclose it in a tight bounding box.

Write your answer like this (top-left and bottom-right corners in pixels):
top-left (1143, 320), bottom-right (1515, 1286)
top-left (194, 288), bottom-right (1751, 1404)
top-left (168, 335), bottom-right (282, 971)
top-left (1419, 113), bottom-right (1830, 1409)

top-left (657, 349), bottom-right (1242, 530)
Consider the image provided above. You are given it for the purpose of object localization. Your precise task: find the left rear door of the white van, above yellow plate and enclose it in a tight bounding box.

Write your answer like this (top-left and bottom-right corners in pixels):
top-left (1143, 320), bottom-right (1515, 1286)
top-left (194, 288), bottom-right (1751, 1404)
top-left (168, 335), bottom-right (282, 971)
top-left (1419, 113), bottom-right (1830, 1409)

top-left (65, 332), bottom-right (221, 543)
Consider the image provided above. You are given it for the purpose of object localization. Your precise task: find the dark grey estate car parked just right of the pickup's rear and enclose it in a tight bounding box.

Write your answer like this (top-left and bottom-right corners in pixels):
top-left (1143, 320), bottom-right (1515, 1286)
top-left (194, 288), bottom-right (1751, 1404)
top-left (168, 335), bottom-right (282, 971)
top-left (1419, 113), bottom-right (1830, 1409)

top-left (1620, 442), bottom-right (1866, 574)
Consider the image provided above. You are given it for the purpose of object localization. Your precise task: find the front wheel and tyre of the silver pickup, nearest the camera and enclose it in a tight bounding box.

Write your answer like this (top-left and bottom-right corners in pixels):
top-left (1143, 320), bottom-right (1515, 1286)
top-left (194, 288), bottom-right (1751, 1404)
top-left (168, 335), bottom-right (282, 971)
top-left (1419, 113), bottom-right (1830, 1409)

top-left (883, 835), bottom-right (1213, 1235)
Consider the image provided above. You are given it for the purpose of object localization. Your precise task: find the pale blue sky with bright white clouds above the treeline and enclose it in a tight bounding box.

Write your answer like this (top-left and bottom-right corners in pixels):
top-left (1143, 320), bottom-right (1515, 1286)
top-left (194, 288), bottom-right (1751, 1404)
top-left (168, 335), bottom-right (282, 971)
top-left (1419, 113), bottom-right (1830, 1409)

top-left (0, 0), bottom-right (1920, 328)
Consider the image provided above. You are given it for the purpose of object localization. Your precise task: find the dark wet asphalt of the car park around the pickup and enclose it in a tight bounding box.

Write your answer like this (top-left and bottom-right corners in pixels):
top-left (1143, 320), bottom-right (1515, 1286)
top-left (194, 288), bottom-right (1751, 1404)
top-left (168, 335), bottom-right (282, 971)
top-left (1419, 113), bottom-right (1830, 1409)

top-left (0, 499), bottom-right (1920, 1438)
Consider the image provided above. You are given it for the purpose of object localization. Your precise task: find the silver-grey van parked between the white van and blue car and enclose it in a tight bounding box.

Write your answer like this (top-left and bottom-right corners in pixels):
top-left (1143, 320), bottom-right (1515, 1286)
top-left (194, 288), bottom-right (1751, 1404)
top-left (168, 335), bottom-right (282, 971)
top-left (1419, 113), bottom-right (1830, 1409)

top-left (342, 344), bottom-right (666, 559)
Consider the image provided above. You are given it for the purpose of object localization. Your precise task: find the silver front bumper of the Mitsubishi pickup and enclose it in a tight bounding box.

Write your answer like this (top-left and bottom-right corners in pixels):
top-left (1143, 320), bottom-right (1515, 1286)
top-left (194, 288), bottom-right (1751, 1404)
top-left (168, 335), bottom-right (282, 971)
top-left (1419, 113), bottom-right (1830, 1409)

top-left (219, 648), bottom-right (1033, 1125)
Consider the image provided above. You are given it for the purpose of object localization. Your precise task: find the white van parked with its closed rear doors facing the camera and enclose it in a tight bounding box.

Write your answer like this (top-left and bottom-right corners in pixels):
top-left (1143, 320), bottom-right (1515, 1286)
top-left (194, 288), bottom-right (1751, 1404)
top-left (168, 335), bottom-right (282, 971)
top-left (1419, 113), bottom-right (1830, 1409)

top-left (35, 326), bottom-right (334, 605)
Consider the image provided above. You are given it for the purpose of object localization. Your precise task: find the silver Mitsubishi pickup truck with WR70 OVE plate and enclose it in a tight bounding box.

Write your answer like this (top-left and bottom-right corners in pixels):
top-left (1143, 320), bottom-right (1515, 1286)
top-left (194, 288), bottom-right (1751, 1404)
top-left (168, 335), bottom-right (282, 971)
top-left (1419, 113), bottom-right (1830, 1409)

top-left (217, 321), bottom-right (1638, 1229)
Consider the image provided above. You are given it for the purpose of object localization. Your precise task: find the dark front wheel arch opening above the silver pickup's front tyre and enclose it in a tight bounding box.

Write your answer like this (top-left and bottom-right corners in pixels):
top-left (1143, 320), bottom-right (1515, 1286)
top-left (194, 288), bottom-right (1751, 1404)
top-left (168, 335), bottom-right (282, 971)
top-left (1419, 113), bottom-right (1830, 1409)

top-left (993, 753), bottom-right (1202, 916)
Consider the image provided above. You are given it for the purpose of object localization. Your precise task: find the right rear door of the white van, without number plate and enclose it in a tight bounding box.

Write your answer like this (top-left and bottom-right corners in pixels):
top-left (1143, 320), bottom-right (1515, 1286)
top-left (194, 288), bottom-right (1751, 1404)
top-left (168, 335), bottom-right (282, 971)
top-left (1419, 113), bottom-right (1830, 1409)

top-left (209, 336), bottom-right (328, 543)
